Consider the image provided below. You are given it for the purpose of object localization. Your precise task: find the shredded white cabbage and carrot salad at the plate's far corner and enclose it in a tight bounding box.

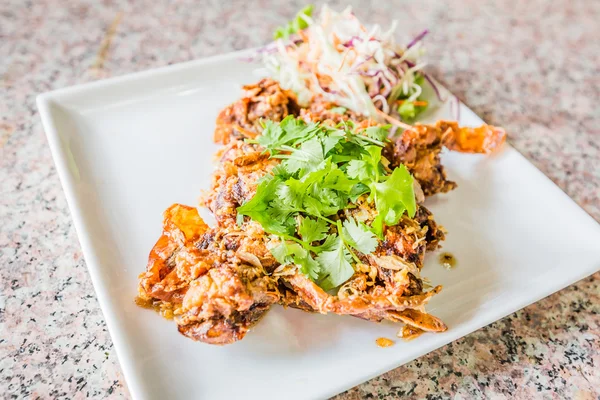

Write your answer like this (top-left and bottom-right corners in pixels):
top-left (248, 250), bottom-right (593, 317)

top-left (262, 6), bottom-right (427, 126)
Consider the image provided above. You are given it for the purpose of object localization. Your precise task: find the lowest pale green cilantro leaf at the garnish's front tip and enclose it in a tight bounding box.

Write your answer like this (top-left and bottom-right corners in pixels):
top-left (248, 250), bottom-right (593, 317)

top-left (317, 236), bottom-right (354, 290)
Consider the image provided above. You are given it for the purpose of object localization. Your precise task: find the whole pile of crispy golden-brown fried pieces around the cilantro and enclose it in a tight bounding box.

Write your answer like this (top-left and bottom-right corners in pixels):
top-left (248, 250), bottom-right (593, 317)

top-left (139, 79), bottom-right (504, 344)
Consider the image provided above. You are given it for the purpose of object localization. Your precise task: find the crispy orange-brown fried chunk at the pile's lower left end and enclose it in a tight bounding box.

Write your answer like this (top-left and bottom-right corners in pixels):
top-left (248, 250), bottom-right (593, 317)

top-left (138, 204), bottom-right (279, 344)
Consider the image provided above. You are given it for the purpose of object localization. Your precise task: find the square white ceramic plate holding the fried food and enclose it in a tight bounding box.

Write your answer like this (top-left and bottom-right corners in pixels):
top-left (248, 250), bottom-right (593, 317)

top-left (38, 52), bottom-right (600, 399)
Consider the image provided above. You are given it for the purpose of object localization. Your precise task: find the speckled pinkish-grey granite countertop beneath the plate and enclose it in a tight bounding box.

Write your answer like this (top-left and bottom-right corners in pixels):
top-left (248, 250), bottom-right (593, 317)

top-left (0, 0), bottom-right (600, 400)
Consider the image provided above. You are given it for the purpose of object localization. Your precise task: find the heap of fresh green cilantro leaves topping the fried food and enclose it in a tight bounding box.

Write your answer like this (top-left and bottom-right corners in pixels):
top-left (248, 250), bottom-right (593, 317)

top-left (237, 116), bottom-right (416, 290)
